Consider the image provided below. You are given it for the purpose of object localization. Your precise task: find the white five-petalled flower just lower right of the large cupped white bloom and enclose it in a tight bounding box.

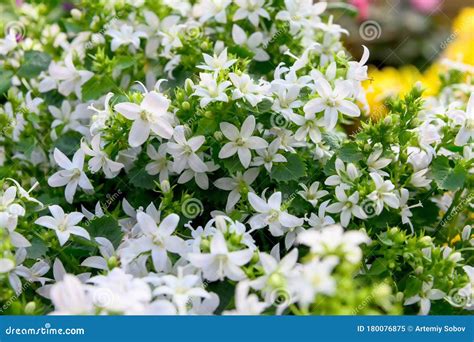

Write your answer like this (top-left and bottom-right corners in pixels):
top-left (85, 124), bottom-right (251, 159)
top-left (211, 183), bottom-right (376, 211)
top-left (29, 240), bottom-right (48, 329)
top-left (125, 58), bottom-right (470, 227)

top-left (167, 126), bottom-right (208, 174)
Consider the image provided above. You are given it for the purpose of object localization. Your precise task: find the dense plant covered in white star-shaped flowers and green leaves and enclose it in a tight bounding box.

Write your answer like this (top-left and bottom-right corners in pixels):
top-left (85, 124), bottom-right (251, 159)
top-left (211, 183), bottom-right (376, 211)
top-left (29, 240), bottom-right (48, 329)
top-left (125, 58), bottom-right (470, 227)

top-left (0, 0), bottom-right (474, 315)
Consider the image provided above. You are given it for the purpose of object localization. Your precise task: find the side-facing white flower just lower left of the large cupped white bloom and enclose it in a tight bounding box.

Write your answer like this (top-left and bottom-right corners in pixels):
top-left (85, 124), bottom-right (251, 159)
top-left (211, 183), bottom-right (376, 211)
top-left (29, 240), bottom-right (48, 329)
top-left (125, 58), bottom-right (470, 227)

top-left (81, 135), bottom-right (124, 178)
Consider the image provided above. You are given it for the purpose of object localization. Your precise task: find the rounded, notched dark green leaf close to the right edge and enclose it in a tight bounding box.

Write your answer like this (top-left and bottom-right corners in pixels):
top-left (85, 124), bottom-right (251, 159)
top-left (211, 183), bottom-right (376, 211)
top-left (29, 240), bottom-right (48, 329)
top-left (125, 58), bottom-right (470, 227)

top-left (431, 156), bottom-right (467, 191)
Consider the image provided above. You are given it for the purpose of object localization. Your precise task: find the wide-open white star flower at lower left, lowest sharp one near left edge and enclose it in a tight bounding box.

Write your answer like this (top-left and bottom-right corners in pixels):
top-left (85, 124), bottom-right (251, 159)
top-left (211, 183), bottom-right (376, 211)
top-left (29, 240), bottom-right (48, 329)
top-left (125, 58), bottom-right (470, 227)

top-left (35, 205), bottom-right (91, 246)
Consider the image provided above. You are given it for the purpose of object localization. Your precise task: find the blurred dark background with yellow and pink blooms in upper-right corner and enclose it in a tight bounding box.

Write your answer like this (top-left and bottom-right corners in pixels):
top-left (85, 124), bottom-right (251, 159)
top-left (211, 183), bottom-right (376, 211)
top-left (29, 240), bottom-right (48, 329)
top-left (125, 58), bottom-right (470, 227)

top-left (329, 0), bottom-right (474, 117)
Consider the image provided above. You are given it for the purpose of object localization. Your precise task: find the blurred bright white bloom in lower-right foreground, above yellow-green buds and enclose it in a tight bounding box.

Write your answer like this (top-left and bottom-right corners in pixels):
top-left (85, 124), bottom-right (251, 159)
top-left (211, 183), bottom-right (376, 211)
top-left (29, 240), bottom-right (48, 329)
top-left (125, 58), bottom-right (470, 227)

top-left (297, 224), bottom-right (371, 264)
